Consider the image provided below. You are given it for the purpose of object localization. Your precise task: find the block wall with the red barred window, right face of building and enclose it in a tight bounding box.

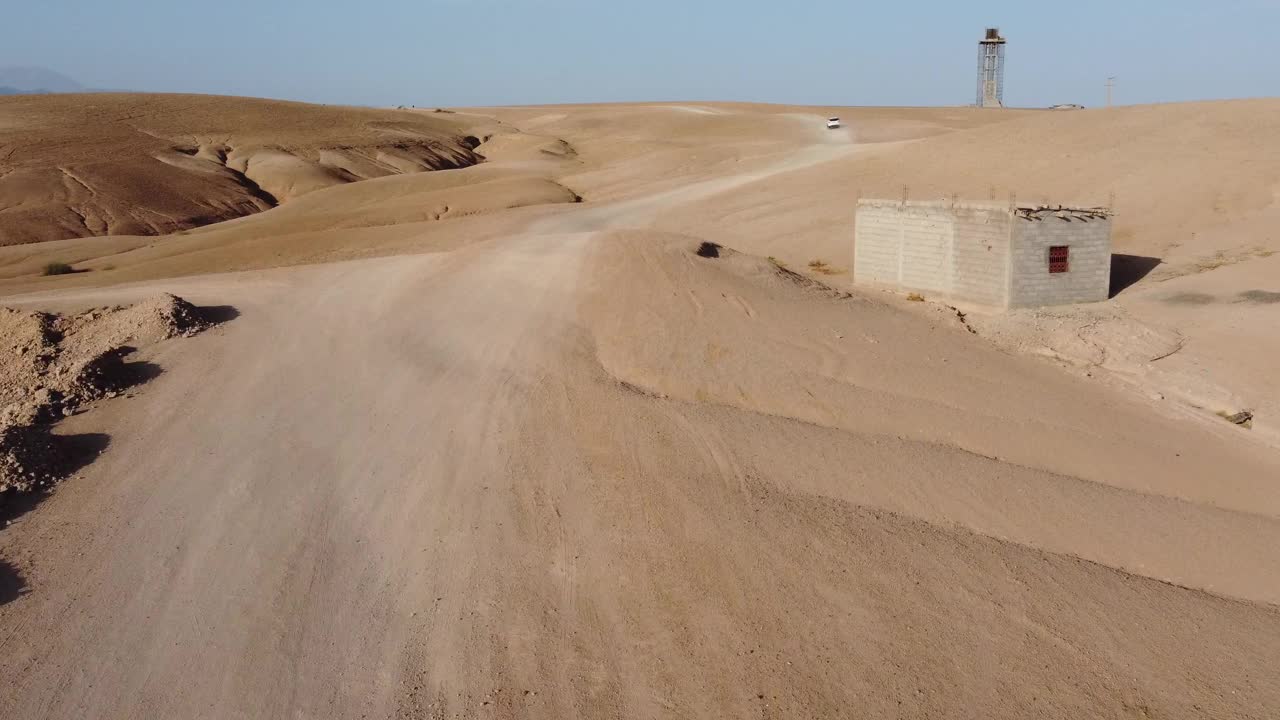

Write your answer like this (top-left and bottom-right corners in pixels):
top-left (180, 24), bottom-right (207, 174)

top-left (1009, 211), bottom-right (1111, 307)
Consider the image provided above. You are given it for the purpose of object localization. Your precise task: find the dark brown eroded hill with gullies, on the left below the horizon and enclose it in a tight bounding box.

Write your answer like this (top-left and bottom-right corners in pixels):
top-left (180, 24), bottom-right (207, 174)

top-left (0, 94), bottom-right (494, 245)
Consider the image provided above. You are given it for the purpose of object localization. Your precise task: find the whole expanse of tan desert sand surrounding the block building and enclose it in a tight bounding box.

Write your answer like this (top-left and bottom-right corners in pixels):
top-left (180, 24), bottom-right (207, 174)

top-left (0, 96), bottom-right (1280, 719)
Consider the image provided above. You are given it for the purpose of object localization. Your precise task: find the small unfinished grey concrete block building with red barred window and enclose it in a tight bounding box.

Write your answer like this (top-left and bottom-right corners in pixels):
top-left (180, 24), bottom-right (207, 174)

top-left (854, 200), bottom-right (1111, 309)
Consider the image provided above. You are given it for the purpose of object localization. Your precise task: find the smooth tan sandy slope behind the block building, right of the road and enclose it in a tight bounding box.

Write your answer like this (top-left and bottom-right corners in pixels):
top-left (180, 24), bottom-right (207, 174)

top-left (611, 100), bottom-right (1280, 443)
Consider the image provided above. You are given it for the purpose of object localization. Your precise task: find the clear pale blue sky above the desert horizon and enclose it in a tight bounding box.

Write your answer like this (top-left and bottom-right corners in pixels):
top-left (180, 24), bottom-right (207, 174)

top-left (0, 0), bottom-right (1280, 106)
